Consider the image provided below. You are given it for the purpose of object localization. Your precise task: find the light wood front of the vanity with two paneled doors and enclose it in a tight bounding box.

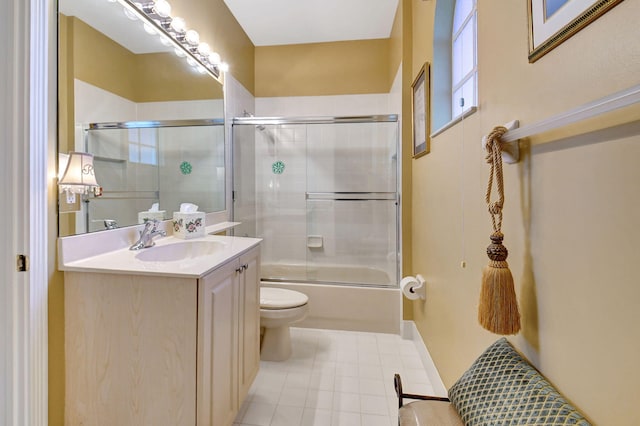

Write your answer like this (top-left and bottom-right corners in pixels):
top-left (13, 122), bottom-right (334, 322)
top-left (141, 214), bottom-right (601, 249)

top-left (198, 248), bottom-right (260, 425)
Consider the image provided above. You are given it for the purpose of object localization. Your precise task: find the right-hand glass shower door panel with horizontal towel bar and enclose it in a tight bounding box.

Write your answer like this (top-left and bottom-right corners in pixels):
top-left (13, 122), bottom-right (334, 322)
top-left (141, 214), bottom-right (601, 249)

top-left (305, 122), bottom-right (398, 286)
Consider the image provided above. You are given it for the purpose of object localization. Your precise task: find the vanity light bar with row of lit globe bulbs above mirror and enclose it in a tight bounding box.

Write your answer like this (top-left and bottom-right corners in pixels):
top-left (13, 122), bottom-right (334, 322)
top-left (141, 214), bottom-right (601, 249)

top-left (117, 0), bottom-right (229, 81)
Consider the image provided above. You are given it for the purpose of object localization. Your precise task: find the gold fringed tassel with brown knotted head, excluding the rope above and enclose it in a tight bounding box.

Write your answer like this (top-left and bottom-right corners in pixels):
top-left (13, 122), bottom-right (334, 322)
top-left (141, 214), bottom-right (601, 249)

top-left (478, 232), bottom-right (520, 335)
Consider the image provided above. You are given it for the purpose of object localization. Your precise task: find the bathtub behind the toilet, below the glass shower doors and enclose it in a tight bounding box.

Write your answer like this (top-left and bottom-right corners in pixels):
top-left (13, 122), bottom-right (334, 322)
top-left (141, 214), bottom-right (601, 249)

top-left (260, 263), bottom-right (402, 334)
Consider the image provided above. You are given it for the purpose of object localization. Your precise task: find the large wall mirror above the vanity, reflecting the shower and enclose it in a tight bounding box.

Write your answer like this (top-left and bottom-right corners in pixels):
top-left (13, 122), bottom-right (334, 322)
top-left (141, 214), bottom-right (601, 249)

top-left (58, 0), bottom-right (225, 236)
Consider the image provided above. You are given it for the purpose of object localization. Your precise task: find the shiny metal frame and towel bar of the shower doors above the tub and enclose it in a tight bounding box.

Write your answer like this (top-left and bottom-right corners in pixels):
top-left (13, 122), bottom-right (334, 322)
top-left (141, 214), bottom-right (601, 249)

top-left (229, 114), bottom-right (402, 289)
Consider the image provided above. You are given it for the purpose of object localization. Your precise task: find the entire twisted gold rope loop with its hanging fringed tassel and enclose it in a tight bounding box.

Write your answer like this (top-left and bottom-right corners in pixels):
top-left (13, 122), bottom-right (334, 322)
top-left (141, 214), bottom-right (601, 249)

top-left (478, 126), bottom-right (520, 335)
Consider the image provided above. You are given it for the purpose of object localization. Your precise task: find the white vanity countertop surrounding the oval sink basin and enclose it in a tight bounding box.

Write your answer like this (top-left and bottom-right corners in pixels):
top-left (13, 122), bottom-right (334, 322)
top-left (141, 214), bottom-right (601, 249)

top-left (58, 235), bottom-right (262, 278)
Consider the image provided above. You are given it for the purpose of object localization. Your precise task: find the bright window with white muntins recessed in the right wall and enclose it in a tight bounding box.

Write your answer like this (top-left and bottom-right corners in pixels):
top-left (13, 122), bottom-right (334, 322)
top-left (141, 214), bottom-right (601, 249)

top-left (451, 0), bottom-right (478, 119)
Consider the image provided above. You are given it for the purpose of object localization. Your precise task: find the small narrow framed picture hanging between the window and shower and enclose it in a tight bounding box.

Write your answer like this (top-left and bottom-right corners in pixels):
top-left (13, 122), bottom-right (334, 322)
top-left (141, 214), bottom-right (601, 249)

top-left (411, 62), bottom-right (431, 158)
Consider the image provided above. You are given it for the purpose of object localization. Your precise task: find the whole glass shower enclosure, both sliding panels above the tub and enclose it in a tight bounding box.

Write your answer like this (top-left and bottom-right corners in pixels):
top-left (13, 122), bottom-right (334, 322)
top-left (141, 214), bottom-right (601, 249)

top-left (233, 118), bottom-right (399, 287)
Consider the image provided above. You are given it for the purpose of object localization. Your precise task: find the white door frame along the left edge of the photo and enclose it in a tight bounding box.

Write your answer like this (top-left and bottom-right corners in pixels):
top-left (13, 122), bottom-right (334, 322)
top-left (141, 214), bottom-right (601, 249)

top-left (0, 0), bottom-right (57, 426)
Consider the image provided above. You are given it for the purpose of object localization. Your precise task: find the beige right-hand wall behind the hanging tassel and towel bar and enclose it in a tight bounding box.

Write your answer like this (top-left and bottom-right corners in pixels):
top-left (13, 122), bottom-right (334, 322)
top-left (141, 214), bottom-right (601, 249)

top-left (412, 1), bottom-right (640, 425)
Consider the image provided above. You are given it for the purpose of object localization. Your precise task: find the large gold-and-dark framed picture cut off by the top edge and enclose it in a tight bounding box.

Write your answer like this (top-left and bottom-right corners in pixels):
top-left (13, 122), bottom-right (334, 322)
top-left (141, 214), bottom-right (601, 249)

top-left (528, 0), bottom-right (622, 62)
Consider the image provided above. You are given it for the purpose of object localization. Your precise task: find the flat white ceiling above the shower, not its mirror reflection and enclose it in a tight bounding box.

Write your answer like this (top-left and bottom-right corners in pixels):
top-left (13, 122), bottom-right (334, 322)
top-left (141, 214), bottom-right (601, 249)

top-left (224, 0), bottom-right (398, 46)
